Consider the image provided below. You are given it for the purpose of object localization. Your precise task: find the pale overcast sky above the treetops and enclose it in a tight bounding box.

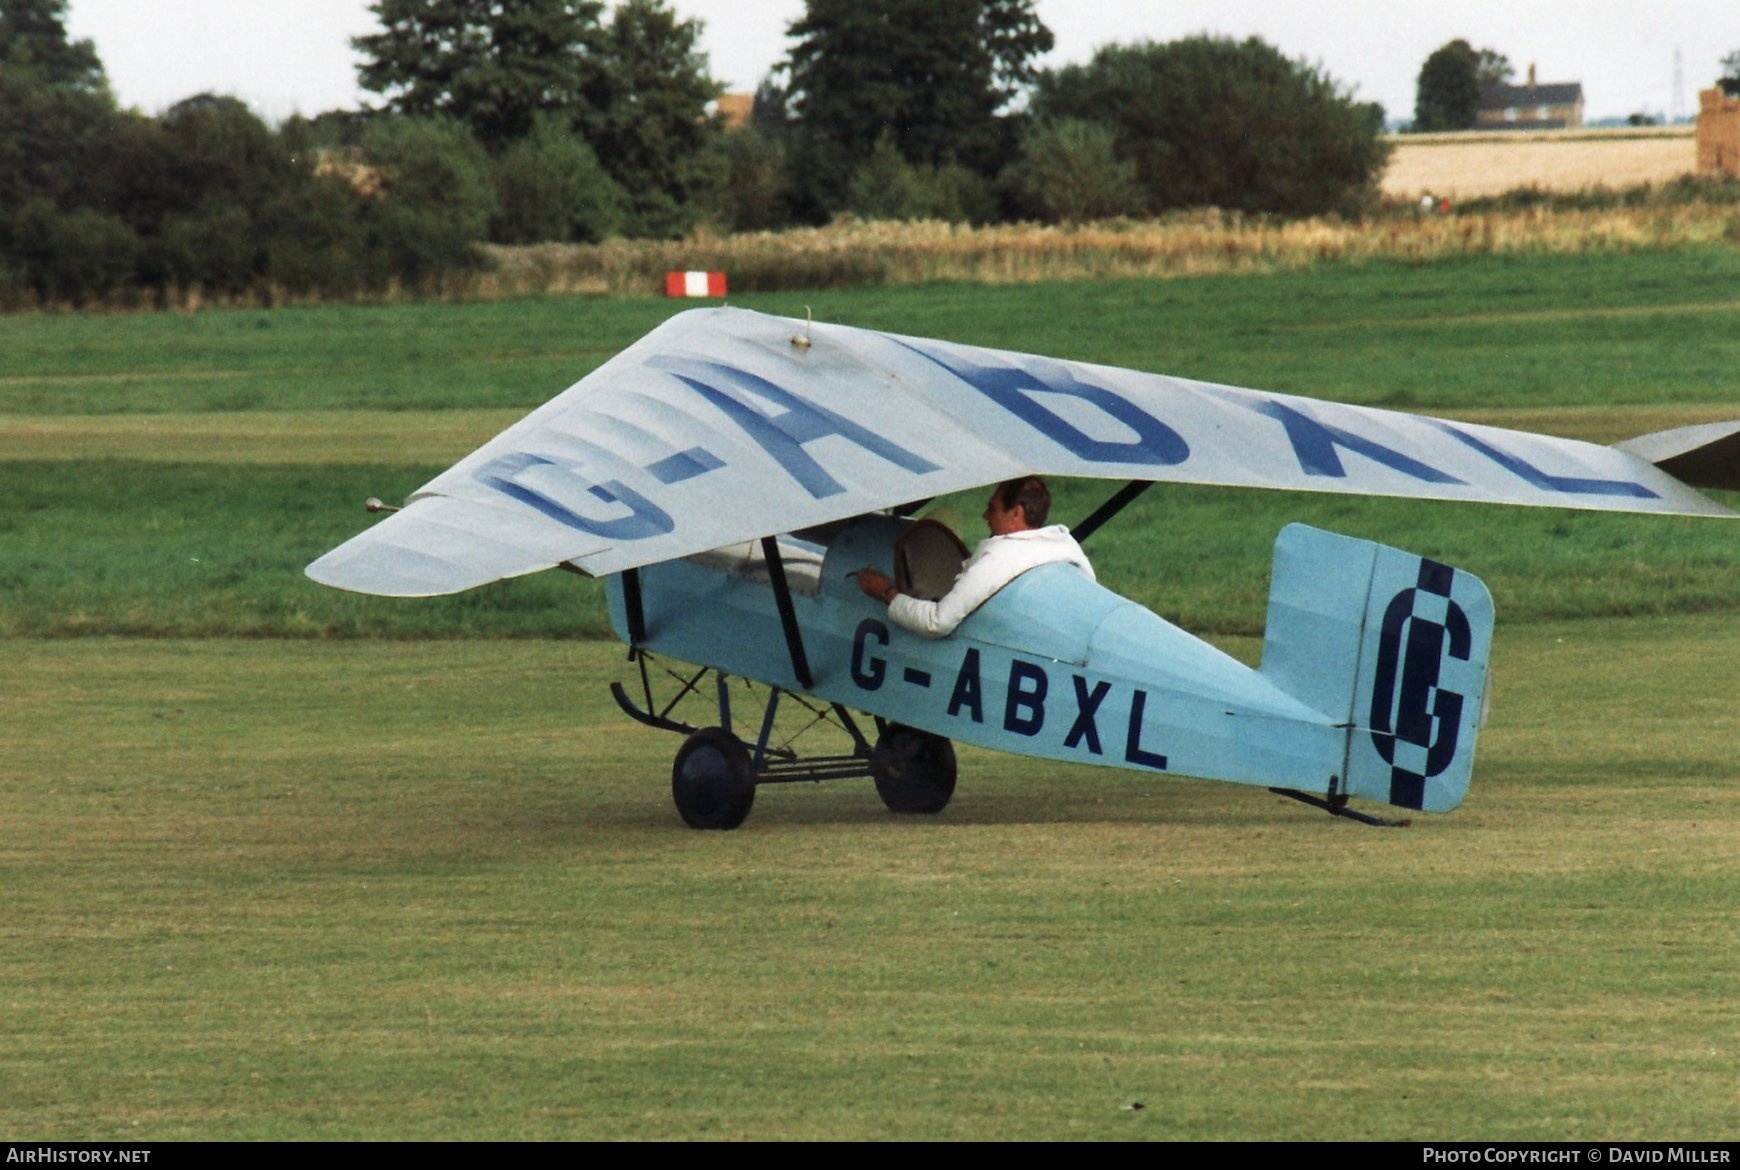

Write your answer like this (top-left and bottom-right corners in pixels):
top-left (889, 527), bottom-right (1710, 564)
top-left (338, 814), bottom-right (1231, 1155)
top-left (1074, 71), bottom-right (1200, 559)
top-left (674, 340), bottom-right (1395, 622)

top-left (68, 0), bottom-right (1740, 122)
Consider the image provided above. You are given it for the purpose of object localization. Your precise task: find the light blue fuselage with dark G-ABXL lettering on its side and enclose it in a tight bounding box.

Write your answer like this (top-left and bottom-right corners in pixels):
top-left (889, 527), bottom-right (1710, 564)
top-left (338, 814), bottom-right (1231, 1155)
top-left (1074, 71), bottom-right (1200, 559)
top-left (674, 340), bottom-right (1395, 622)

top-left (609, 515), bottom-right (1349, 792)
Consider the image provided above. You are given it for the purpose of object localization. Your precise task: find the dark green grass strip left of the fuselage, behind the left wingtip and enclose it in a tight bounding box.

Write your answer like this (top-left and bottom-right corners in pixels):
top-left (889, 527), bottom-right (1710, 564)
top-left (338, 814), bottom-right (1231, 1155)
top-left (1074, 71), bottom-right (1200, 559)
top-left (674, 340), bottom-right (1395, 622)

top-left (0, 460), bottom-right (609, 637)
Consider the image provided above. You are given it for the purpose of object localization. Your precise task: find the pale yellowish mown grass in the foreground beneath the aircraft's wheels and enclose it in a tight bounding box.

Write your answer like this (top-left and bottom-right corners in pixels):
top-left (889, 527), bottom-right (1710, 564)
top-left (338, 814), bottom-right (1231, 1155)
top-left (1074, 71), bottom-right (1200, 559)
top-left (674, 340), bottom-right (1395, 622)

top-left (0, 626), bottom-right (1740, 1144)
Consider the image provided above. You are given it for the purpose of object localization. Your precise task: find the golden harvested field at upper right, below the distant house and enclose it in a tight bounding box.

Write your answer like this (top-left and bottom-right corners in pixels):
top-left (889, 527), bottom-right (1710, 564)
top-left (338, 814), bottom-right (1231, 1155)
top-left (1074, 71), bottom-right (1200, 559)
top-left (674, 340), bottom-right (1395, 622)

top-left (1383, 125), bottom-right (1698, 200)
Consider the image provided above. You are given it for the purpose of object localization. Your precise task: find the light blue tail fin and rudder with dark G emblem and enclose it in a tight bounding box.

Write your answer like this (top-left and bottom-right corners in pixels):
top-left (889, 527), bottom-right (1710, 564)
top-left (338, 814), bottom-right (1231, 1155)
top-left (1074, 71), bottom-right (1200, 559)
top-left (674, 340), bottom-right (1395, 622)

top-left (1262, 524), bottom-right (1493, 813)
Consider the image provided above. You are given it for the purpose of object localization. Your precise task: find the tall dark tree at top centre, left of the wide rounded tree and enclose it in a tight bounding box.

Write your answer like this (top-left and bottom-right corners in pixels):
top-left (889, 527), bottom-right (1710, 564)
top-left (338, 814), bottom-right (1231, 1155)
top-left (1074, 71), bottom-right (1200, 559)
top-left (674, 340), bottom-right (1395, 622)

top-left (786, 0), bottom-right (1053, 209)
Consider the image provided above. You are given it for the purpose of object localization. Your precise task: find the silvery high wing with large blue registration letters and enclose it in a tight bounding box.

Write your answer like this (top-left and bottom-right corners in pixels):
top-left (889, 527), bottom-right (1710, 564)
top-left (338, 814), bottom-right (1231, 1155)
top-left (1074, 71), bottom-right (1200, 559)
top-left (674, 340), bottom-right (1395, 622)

top-left (308, 308), bottom-right (1733, 597)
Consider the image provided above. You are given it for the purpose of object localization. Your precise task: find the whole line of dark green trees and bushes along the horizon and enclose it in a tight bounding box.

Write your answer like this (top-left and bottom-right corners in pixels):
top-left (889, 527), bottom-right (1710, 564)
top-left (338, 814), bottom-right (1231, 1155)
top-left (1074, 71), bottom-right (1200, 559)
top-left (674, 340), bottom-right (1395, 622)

top-left (0, 0), bottom-right (1385, 305)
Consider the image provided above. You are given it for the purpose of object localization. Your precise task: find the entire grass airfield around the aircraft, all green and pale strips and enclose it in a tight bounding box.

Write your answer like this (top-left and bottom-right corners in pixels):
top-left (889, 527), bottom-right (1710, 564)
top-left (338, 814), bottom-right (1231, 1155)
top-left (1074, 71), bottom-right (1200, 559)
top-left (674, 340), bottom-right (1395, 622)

top-left (0, 249), bottom-right (1740, 1142)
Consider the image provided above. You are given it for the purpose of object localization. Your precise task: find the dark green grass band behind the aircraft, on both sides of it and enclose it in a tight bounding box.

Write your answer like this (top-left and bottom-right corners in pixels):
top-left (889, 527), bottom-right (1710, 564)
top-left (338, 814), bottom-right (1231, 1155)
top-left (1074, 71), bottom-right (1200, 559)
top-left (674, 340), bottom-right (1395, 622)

top-left (0, 460), bottom-right (1740, 639)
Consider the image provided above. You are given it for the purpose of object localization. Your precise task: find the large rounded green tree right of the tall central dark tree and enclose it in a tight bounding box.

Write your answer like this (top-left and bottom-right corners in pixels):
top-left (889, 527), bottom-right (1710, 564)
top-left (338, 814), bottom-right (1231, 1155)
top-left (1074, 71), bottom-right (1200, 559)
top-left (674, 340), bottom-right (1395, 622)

top-left (1034, 37), bottom-right (1389, 216)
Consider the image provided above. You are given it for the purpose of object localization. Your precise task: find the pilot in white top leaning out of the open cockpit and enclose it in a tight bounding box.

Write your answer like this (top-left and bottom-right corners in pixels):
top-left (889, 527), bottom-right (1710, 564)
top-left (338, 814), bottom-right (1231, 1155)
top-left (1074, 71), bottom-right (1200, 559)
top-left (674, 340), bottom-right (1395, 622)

top-left (858, 475), bottom-right (1093, 637)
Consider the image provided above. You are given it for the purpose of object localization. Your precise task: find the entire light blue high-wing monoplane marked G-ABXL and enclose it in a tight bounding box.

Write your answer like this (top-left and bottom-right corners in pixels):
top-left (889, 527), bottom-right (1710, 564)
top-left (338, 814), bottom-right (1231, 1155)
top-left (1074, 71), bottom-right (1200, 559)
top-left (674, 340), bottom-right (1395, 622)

top-left (308, 308), bottom-right (1740, 829)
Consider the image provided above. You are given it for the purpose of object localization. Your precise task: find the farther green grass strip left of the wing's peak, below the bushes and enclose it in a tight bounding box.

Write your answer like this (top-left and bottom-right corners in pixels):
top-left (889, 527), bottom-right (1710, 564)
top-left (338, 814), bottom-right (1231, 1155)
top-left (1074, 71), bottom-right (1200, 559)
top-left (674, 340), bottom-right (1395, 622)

top-left (0, 301), bottom-right (672, 414)
